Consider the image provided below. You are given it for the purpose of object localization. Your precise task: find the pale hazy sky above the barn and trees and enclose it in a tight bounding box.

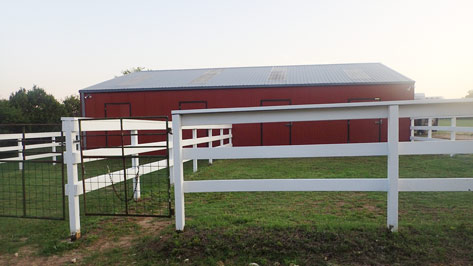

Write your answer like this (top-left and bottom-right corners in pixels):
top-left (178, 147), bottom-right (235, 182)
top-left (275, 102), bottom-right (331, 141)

top-left (0, 0), bottom-right (473, 99)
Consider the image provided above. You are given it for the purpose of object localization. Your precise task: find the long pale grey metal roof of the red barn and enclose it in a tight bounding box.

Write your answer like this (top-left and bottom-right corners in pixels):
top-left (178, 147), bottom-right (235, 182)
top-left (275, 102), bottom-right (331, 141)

top-left (80, 63), bottom-right (414, 93)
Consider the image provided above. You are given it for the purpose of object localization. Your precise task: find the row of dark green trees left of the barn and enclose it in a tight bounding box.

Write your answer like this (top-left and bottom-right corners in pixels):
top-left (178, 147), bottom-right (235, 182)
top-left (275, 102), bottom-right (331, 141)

top-left (0, 85), bottom-right (81, 124)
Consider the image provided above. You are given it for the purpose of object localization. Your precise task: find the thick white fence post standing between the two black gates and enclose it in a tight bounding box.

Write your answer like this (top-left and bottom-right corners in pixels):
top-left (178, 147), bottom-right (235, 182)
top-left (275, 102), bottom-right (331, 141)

top-left (61, 117), bottom-right (81, 240)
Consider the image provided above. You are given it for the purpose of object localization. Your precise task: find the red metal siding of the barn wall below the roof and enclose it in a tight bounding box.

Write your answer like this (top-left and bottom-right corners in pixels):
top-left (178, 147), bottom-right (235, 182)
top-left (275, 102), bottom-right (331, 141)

top-left (85, 85), bottom-right (414, 146)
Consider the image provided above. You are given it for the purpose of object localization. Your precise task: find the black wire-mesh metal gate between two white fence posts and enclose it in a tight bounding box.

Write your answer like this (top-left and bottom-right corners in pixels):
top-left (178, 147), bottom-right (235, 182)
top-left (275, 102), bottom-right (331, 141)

top-left (79, 117), bottom-right (172, 217)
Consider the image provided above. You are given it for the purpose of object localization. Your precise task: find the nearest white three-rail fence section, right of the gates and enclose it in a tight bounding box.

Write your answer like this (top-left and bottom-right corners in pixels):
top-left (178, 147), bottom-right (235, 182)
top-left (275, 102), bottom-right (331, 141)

top-left (172, 99), bottom-right (473, 231)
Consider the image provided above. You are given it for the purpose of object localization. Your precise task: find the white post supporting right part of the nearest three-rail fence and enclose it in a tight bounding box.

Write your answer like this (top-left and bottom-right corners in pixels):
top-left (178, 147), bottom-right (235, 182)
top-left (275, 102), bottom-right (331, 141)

top-left (387, 105), bottom-right (399, 232)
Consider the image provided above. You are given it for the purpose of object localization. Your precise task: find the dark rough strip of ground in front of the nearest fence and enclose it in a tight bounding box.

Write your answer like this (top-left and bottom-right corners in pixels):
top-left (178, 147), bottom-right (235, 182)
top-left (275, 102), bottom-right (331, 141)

top-left (137, 227), bottom-right (471, 265)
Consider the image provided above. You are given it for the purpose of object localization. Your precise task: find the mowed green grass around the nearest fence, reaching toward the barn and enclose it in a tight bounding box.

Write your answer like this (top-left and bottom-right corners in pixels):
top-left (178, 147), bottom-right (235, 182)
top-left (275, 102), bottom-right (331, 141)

top-left (0, 155), bottom-right (473, 265)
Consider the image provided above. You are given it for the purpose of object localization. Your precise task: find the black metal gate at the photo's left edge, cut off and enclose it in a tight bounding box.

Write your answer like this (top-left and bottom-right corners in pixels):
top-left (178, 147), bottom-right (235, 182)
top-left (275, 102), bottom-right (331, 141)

top-left (0, 124), bottom-right (66, 220)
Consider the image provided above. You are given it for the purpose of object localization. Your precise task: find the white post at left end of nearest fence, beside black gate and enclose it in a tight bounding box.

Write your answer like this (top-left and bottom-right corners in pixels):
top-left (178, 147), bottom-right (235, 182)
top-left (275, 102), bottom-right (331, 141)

top-left (172, 115), bottom-right (185, 231)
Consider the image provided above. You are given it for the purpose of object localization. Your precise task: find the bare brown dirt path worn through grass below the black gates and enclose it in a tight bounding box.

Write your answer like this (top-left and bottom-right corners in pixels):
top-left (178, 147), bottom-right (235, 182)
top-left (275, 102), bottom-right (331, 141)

top-left (0, 217), bottom-right (171, 266)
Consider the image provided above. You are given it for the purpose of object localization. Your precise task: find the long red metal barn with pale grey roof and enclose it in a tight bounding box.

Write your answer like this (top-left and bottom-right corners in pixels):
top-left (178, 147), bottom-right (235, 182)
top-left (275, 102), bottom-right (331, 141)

top-left (80, 63), bottom-right (415, 146)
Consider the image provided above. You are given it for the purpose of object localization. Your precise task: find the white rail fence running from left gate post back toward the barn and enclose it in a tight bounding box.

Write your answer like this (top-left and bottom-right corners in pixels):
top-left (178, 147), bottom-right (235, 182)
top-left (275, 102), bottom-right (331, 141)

top-left (62, 117), bottom-right (232, 239)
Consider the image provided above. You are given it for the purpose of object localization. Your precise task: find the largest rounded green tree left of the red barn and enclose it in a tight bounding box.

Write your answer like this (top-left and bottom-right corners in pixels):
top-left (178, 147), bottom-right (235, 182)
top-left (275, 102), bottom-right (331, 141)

top-left (10, 85), bottom-right (64, 123)
